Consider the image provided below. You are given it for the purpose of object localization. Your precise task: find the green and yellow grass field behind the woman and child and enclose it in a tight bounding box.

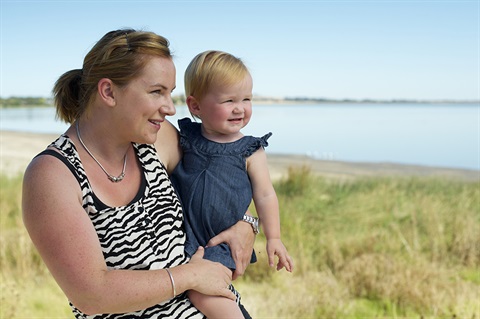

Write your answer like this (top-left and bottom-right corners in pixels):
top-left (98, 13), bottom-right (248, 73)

top-left (0, 167), bottom-right (480, 319)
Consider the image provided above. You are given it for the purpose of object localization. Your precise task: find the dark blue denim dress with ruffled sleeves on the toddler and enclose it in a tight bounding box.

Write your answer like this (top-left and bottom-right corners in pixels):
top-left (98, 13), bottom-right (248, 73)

top-left (171, 118), bottom-right (272, 270)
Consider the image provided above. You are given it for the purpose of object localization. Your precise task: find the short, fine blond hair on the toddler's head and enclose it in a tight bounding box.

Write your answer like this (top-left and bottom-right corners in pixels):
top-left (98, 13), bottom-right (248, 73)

top-left (184, 50), bottom-right (250, 100)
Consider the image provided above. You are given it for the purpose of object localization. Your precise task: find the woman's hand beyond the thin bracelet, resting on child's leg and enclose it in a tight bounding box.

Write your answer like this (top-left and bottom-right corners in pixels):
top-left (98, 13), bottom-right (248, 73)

top-left (189, 247), bottom-right (236, 300)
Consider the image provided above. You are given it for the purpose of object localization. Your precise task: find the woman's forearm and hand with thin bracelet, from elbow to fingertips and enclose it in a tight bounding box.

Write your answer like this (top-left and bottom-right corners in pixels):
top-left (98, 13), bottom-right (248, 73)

top-left (69, 254), bottom-right (235, 314)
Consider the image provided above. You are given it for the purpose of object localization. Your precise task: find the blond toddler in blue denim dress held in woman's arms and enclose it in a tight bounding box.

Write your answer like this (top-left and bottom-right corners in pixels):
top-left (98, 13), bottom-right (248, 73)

top-left (172, 51), bottom-right (293, 319)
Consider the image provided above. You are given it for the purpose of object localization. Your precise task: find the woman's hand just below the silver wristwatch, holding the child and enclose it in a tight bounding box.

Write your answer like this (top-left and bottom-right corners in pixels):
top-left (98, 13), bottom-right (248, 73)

top-left (207, 221), bottom-right (255, 280)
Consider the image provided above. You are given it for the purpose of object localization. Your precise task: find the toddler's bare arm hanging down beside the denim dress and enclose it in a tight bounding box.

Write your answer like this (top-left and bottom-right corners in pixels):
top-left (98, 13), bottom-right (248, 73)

top-left (247, 148), bottom-right (293, 272)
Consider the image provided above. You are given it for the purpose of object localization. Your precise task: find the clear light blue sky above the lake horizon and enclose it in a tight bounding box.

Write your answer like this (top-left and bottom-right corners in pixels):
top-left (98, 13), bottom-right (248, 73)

top-left (0, 0), bottom-right (480, 100)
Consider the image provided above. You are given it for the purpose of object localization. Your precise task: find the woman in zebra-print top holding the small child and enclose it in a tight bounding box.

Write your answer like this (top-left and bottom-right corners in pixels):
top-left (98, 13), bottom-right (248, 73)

top-left (23, 29), bottom-right (254, 318)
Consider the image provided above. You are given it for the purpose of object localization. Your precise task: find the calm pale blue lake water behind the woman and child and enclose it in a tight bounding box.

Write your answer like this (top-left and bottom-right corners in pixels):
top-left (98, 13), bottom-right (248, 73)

top-left (0, 104), bottom-right (480, 170)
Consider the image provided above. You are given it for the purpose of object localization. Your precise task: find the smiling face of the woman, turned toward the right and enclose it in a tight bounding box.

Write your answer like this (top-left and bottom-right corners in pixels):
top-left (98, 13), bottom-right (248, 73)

top-left (116, 57), bottom-right (176, 144)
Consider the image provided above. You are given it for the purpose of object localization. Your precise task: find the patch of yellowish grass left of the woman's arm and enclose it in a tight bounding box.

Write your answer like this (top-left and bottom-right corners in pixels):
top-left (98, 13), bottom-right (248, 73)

top-left (0, 175), bottom-right (71, 318)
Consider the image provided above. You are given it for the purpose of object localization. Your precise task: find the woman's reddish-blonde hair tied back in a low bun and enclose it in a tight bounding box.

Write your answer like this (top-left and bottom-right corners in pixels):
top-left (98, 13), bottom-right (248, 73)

top-left (53, 29), bottom-right (172, 123)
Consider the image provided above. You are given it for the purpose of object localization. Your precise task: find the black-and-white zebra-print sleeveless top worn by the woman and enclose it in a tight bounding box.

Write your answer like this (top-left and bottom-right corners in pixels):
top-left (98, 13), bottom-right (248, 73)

top-left (39, 135), bottom-right (205, 319)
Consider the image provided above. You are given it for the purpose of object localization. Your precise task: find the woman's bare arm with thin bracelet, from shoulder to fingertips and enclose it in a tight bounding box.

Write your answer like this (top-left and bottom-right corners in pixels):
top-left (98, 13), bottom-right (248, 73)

top-left (22, 156), bottom-right (234, 314)
